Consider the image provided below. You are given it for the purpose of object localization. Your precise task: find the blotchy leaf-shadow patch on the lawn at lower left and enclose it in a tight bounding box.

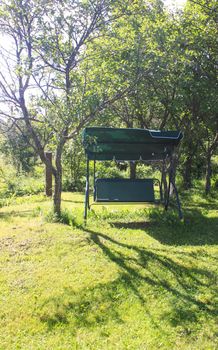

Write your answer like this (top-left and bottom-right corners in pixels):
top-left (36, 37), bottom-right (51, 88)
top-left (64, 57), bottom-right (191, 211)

top-left (39, 276), bottom-right (125, 332)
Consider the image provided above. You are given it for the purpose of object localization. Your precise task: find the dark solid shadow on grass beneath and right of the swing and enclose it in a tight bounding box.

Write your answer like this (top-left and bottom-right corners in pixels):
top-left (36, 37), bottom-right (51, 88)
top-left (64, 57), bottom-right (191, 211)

top-left (111, 209), bottom-right (218, 246)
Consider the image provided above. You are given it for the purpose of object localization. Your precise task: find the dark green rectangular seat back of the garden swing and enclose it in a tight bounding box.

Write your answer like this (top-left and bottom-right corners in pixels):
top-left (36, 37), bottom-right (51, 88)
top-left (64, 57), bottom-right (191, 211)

top-left (94, 179), bottom-right (155, 203)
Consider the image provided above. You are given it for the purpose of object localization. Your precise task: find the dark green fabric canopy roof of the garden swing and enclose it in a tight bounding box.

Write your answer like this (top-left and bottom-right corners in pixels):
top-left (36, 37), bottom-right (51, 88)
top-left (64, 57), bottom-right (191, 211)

top-left (83, 127), bottom-right (183, 160)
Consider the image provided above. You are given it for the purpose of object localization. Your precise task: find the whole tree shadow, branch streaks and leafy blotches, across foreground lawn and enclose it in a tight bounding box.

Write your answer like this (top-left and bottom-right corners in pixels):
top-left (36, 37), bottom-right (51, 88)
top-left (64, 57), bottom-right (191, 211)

top-left (40, 221), bottom-right (216, 334)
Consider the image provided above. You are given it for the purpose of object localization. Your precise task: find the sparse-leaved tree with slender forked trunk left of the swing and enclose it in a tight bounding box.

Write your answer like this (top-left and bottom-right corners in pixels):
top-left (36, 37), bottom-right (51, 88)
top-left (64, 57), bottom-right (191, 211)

top-left (0, 0), bottom-right (129, 216)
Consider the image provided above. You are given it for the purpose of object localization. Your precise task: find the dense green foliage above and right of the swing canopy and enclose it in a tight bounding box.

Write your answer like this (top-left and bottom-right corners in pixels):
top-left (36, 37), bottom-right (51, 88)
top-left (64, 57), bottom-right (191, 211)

top-left (89, 1), bottom-right (218, 193)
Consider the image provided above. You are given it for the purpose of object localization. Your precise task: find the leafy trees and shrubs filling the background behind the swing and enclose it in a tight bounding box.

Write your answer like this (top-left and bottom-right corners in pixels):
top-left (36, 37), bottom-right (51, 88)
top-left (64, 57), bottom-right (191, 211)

top-left (0, 0), bottom-right (218, 214)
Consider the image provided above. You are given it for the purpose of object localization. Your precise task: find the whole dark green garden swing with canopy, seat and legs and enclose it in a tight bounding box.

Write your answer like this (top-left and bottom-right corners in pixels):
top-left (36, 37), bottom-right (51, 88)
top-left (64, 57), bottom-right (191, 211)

top-left (83, 127), bottom-right (183, 220)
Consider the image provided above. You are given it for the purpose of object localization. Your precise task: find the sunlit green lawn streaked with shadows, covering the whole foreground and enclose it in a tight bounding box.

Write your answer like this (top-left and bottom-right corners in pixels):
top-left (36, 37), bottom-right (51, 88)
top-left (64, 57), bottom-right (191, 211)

top-left (0, 192), bottom-right (218, 350)
